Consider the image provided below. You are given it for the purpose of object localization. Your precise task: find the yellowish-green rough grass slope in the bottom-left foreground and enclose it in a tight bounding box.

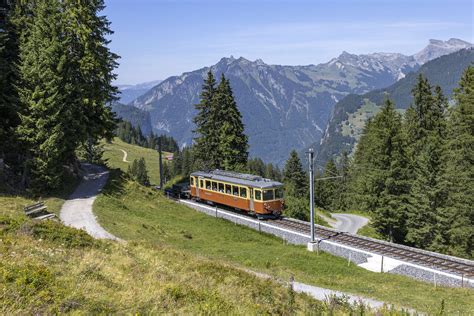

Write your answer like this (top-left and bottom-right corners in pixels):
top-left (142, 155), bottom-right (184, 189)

top-left (0, 188), bottom-right (370, 315)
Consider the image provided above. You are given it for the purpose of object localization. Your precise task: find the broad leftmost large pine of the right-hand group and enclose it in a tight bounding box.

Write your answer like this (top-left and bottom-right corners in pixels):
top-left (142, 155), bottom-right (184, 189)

top-left (350, 100), bottom-right (410, 241)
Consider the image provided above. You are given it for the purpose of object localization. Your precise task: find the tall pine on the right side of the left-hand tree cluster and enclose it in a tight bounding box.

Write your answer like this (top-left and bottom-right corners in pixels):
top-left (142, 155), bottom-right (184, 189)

top-left (61, 0), bottom-right (118, 146)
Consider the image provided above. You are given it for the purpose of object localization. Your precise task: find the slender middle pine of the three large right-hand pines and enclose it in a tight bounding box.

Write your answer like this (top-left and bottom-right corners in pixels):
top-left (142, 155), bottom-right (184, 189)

top-left (406, 75), bottom-right (447, 250)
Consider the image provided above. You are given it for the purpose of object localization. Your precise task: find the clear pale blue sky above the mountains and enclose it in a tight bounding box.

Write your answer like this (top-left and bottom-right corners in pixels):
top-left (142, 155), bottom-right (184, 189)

top-left (103, 0), bottom-right (474, 84)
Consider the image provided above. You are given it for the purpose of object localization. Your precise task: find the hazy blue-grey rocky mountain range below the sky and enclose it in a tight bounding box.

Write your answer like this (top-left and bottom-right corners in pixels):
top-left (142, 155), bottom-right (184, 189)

top-left (114, 39), bottom-right (472, 164)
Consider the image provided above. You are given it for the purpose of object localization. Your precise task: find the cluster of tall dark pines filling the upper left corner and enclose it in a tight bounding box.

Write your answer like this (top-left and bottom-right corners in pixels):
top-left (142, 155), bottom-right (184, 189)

top-left (0, 0), bottom-right (118, 194)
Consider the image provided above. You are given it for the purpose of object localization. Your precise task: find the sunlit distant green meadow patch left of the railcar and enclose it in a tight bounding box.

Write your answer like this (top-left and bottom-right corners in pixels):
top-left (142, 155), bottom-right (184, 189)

top-left (103, 137), bottom-right (170, 185)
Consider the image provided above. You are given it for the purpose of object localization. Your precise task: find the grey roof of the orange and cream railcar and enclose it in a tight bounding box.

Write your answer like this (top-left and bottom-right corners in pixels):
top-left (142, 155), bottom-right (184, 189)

top-left (191, 169), bottom-right (283, 189)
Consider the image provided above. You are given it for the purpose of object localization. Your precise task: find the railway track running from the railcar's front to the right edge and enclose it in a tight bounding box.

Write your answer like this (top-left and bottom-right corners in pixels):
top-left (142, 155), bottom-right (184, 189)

top-left (268, 218), bottom-right (474, 278)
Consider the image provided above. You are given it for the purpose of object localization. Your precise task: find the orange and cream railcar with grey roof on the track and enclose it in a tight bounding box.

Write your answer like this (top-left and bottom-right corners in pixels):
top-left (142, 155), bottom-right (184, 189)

top-left (190, 170), bottom-right (284, 217)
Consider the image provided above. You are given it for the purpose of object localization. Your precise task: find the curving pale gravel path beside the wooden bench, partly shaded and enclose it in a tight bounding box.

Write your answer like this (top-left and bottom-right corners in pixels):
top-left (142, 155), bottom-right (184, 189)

top-left (60, 164), bottom-right (120, 240)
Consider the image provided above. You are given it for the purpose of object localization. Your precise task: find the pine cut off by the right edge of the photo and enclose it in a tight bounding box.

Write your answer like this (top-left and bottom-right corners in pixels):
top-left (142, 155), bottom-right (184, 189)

top-left (442, 66), bottom-right (474, 259)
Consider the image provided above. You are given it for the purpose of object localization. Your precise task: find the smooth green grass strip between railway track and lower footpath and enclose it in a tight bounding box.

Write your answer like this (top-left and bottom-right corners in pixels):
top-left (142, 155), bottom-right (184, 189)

top-left (94, 173), bottom-right (474, 314)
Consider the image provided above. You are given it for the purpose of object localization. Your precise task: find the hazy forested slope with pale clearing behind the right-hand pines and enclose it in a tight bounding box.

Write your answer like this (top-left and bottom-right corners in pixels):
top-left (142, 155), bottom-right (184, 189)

top-left (314, 48), bottom-right (474, 163)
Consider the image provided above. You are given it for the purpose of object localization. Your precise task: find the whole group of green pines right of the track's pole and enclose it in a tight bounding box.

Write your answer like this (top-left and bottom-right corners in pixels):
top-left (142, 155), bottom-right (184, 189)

top-left (320, 66), bottom-right (474, 258)
